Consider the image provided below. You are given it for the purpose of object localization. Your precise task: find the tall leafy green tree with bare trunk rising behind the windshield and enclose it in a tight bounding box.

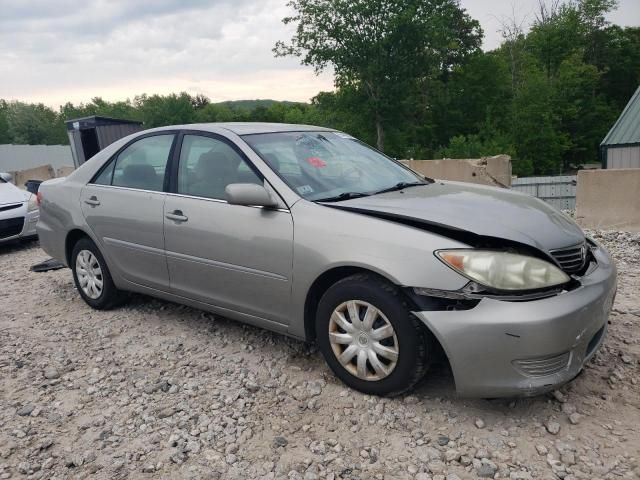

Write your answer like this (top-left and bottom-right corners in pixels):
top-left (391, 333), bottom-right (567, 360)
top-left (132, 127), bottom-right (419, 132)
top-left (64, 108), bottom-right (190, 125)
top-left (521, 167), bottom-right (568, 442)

top-left (274, 0), bottom-right (482, 150)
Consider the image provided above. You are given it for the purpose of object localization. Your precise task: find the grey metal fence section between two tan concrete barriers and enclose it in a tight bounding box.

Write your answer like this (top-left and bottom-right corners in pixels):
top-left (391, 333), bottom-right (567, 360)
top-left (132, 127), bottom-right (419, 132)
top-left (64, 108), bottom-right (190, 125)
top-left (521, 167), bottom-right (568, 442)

top-left (511, 175), bottom-right (578, 210)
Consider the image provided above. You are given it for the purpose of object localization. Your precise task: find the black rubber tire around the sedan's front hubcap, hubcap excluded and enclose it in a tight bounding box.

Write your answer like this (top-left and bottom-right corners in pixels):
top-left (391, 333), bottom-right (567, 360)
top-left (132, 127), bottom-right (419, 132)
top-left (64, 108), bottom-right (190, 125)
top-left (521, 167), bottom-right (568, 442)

top-left (315, 274), bottom-right (432, 396)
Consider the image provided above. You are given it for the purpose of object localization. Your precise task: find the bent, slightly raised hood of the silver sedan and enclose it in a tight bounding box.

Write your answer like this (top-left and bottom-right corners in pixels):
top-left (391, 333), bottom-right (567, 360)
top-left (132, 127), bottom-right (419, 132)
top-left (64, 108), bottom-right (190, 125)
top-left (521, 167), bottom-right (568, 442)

top-left (333, 181), bottom-right (585, 251)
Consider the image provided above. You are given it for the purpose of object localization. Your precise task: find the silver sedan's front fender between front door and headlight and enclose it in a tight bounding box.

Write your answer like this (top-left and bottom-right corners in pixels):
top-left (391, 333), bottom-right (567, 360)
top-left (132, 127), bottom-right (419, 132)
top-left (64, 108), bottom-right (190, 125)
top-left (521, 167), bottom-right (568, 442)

top-left (290, 200), bottom-right (468, 338)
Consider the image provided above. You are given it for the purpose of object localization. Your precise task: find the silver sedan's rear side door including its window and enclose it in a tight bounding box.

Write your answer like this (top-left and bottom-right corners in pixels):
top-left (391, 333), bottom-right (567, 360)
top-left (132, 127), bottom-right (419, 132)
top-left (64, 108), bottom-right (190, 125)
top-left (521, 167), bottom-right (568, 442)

top-left (81, 132), bottom-right (176, 291)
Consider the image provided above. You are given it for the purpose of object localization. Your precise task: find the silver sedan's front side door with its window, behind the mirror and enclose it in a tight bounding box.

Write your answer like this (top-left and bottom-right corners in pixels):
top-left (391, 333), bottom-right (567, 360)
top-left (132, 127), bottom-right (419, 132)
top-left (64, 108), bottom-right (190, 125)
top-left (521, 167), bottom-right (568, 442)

top-left (164, 135), bottom-right (293, 324)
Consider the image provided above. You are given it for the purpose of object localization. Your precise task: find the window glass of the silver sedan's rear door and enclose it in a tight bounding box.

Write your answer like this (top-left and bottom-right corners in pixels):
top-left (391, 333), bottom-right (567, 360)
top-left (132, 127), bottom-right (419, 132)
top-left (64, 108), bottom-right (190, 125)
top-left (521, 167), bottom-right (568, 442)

top-left (93, 135), bottom-right (174, 192)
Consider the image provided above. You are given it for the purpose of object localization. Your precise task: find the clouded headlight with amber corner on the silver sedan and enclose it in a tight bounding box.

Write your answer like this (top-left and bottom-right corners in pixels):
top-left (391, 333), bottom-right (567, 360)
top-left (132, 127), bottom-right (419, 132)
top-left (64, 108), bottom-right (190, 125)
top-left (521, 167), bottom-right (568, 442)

top-left (436, 250), bottom-right (570, 290)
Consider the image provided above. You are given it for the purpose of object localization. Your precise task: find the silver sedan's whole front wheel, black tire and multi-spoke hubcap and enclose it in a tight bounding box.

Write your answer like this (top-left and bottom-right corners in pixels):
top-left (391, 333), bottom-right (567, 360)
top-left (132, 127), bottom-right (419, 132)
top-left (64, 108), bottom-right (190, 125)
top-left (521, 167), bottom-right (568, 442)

top-left (316, 274), bottom-right (430, 395)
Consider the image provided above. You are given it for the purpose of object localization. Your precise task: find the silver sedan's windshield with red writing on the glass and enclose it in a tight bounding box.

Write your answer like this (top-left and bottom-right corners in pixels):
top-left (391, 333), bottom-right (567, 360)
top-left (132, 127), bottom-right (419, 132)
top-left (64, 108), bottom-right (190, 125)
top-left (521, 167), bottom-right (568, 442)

top-left (242, 132), bottom-right (426, 201)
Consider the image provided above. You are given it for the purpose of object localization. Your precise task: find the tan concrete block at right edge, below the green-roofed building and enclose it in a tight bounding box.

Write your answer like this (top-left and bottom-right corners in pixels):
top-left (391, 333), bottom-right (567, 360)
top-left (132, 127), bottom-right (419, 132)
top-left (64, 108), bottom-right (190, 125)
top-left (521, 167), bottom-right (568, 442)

top-left (576, 168), bottom-right (640, 232)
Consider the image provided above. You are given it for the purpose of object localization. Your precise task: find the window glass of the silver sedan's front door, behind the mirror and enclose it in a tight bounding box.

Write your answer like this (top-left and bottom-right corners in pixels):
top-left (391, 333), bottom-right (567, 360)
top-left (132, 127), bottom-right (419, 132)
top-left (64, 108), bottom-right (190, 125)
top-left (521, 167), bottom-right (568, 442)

top-left (178, 135), bottom-right (263, 200)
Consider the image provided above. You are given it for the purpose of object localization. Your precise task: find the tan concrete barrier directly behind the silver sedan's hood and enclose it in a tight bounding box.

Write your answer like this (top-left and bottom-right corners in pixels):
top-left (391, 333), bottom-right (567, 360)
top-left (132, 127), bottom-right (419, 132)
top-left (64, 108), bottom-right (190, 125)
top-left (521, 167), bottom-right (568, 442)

top-left (401, 155), bottom-right (511, 187)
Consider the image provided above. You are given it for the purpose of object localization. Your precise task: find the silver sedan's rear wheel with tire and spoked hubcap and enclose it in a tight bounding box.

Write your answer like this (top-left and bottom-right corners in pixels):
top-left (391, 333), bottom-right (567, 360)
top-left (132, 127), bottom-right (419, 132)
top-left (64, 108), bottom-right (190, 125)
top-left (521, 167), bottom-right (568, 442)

top-left (70, 238), bottom-right (124, 310)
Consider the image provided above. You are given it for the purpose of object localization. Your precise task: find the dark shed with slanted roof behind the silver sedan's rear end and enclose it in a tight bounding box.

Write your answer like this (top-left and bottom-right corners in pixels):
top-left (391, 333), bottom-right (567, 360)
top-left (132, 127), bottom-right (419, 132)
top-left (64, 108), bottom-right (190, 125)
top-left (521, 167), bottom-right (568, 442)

top-left (65, 115), bottom-right (142, 168)
